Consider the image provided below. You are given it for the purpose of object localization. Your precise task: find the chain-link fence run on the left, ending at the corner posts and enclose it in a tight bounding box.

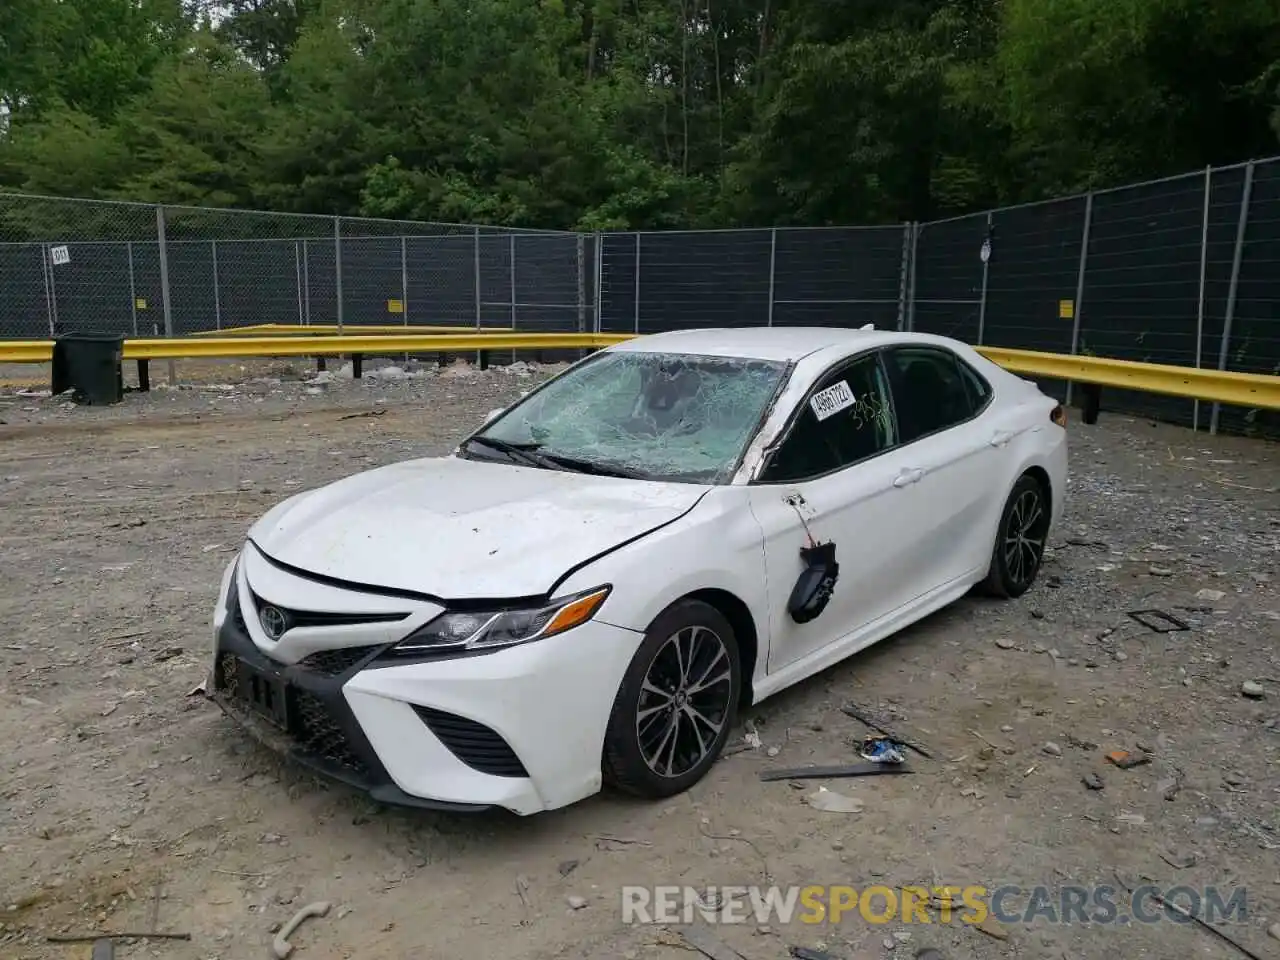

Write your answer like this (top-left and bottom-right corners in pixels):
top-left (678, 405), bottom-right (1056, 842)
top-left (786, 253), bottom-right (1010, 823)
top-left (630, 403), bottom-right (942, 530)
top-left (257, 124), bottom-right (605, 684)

top-left (0, 193), bottom-right (595, 339)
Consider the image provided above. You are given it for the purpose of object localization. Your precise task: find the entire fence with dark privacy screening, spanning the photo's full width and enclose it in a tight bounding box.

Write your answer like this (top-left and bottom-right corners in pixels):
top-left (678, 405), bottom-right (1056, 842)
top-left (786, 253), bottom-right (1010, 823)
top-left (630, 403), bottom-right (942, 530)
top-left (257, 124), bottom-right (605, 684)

top-left (0, 160), bottom-right (1280, 436)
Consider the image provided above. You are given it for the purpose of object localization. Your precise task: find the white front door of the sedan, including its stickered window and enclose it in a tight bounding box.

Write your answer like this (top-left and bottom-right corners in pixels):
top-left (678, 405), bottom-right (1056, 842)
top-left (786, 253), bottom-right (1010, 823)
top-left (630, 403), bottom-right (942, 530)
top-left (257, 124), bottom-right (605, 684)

top-left (751, 353), bottom-right (919, 673)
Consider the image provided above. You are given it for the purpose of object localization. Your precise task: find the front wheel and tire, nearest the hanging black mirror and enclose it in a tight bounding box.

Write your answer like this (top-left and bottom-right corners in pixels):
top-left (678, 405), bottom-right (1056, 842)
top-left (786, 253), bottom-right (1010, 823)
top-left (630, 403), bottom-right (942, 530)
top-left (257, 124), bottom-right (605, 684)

top-left (602, 600), bottom-right (742, 800)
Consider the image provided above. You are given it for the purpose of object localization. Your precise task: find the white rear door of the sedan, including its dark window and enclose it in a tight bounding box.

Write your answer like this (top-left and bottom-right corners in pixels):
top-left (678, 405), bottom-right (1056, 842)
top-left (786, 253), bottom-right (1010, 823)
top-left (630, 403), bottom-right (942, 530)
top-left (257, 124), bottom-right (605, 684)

top-left (884, 346), bottom-right (1012, 599)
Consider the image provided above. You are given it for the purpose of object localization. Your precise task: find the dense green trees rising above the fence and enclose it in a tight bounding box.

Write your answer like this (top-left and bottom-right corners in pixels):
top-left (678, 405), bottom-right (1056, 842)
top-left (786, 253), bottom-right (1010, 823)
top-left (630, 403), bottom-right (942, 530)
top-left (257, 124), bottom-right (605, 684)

top-left (0, 0), bottom-right (1280, 229)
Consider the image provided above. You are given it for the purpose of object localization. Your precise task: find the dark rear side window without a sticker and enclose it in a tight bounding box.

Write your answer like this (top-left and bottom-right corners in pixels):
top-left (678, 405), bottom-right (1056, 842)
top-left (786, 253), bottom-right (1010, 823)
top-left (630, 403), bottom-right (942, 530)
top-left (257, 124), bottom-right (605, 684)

top-left (886, 347), bottom-right (986, 443)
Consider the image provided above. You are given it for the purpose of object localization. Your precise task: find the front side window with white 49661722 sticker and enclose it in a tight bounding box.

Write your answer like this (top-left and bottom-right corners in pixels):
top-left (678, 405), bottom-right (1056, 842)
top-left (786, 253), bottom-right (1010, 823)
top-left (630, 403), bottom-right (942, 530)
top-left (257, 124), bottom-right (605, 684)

top-left (760, 355), bottom-right (895, 483)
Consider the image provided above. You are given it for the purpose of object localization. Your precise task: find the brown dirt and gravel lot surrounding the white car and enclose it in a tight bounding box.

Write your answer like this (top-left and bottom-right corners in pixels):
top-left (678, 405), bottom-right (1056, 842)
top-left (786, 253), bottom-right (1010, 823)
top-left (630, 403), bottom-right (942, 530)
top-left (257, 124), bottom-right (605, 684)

top-left (0, 364), bottom-right (1280, 960)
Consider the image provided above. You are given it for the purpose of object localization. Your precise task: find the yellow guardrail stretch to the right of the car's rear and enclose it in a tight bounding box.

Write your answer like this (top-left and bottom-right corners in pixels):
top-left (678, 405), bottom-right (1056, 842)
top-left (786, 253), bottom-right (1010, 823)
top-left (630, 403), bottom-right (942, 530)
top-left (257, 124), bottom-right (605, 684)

top-left (974, 347), bottom-right (1280, 410)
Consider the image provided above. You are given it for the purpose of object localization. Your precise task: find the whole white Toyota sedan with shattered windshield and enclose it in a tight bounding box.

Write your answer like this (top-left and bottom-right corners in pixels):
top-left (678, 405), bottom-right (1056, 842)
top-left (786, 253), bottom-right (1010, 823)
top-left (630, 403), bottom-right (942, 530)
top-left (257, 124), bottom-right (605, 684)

top-left (207, 328), bottom-right (1066, 814)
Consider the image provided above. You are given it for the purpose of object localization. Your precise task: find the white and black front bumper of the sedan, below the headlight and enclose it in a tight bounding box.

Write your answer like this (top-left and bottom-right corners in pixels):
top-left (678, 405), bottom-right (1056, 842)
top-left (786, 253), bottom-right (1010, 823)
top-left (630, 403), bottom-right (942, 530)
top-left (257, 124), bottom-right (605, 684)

top-left (206, 593), bottom-right (643, 814)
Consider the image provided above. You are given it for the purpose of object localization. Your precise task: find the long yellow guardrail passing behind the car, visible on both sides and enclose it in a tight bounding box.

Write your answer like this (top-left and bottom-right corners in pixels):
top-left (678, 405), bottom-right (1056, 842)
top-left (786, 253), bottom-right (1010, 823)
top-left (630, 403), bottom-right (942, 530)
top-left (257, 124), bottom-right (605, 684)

top-left (0, 328), bottom-right (1280, 410)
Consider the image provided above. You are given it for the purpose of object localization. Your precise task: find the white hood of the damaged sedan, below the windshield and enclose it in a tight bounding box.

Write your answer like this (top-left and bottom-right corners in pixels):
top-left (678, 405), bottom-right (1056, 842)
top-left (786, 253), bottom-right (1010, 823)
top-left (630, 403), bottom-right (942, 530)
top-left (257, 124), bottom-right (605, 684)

top-left (250, 457), bottom-right (709, 599)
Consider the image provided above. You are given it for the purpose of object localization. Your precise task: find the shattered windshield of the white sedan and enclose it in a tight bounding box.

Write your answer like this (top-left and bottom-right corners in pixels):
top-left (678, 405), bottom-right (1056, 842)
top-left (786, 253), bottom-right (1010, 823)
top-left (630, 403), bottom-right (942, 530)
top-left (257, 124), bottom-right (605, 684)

top-left (465, 351), bottom-right (787, 483)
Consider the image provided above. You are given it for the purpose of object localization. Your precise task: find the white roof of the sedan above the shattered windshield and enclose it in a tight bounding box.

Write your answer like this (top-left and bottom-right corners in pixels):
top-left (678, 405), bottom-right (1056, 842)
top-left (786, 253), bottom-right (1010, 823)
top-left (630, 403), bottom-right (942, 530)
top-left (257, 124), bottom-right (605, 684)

top-left (608, 326), bottom-right (960, 362)
